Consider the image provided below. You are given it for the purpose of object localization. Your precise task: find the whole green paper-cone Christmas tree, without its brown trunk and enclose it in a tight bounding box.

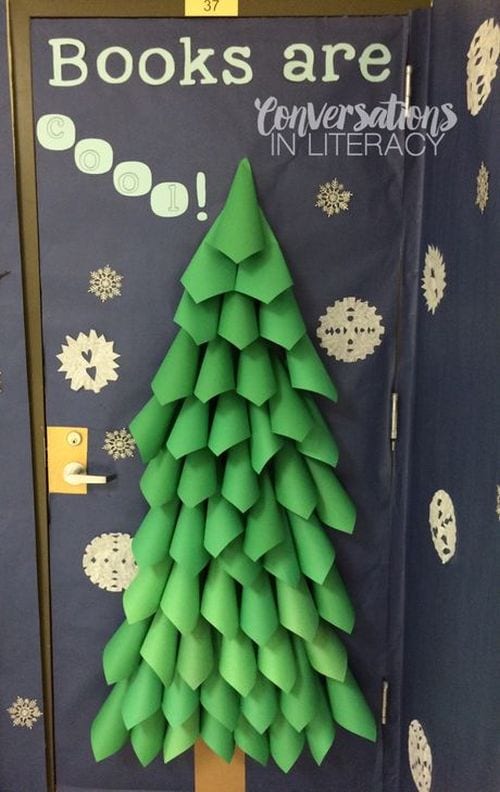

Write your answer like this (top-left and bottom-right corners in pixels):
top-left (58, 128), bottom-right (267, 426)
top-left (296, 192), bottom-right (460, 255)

top-left (92, 160), bottom-right (376, 772)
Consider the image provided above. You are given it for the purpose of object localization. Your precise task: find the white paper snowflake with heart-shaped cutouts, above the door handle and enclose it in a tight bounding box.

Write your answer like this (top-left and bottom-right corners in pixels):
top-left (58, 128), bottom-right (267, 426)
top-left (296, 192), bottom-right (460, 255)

top-left (57, 330), bottom-right (120, 393)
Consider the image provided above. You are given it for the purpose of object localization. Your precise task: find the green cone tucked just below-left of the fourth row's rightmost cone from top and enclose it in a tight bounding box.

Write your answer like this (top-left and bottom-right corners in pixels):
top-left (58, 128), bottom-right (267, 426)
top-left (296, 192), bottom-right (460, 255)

top-left (269, 360), bottom-right (313, 441)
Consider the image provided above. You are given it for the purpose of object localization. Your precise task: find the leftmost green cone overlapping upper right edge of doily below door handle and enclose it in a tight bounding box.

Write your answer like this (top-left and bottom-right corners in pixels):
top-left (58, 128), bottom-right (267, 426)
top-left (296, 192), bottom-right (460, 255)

top-left (132, 500), bottom-right (179, 567)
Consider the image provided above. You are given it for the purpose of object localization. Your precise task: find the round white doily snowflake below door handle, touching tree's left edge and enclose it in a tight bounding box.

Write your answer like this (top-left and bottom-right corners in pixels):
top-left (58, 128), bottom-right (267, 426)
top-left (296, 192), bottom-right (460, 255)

top-left (82, 533), bottom-right (137, 591)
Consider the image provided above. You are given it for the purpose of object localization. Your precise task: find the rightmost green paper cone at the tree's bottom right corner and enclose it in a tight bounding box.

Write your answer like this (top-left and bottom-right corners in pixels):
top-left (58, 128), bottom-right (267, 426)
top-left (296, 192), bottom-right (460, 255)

top-left (326, 670), bottom-right (377, 742)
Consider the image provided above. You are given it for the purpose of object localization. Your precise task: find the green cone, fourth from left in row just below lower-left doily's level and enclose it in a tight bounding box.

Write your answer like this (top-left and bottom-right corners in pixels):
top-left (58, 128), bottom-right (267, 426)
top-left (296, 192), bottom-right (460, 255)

top-left (240, 572), bottom-right (279, 646)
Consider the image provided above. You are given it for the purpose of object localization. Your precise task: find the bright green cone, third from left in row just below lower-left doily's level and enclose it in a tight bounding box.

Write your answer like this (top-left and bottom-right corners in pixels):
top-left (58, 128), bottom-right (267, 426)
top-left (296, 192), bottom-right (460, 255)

top-left (201, 559), bottom-right (239, 636)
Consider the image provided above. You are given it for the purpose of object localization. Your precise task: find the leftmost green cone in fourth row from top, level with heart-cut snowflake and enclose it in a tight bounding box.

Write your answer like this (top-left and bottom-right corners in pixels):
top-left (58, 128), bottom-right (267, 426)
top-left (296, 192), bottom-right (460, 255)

top-left (151, 330), bottom-right (199, 404)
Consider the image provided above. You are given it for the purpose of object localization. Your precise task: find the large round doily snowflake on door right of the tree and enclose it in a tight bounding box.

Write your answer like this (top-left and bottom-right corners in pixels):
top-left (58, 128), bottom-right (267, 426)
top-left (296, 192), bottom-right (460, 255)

top-left (316, 297), bottom-right (385, 363)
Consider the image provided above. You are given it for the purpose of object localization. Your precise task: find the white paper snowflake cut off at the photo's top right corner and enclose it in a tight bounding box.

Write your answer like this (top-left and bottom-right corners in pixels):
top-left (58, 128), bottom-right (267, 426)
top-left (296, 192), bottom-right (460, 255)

top-left (467, 19), bottom-right (500, 115)
